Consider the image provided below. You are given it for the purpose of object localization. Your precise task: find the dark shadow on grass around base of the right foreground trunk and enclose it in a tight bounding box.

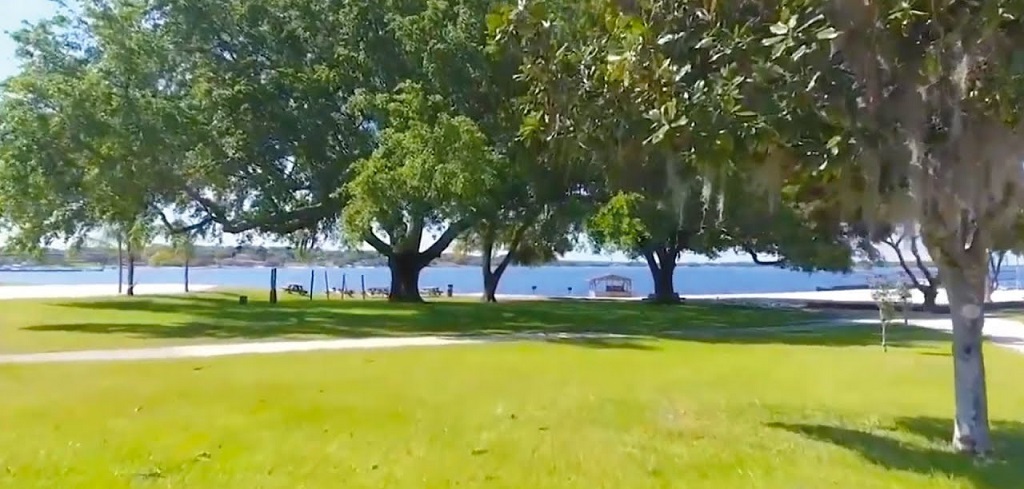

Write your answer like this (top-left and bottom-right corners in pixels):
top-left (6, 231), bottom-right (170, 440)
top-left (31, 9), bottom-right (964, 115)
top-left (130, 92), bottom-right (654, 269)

top-left (769, 417), bottom-right (1024, 489)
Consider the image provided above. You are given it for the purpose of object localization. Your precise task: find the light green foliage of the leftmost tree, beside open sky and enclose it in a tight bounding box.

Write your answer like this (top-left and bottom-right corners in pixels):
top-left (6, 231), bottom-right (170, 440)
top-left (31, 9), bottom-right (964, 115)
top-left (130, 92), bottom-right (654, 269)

top-left (0, 2), bottom-right (186, 249)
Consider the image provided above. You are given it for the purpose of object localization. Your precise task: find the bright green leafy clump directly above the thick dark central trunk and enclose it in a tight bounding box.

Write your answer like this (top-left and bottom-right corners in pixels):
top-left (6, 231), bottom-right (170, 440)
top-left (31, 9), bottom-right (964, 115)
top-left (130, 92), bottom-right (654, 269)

top-left (344, 85), bottom-right (507, 252)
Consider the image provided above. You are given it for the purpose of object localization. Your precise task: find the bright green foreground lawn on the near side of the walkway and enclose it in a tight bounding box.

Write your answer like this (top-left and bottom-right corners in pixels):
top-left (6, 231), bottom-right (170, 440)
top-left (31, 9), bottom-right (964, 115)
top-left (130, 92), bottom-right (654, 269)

top-left (0, 325), bottom-right (1024, 489)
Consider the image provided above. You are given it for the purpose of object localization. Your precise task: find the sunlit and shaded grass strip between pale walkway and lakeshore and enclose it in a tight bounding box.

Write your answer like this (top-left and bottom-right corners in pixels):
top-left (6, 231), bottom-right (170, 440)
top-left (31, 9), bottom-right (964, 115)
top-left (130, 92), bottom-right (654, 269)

top-left (0, 292), bottom-right (815, 352)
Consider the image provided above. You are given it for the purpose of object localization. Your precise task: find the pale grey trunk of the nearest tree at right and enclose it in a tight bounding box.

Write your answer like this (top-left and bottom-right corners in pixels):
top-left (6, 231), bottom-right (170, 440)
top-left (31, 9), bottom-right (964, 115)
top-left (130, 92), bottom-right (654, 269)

top-left (939, 250), bottom-right (991, 456)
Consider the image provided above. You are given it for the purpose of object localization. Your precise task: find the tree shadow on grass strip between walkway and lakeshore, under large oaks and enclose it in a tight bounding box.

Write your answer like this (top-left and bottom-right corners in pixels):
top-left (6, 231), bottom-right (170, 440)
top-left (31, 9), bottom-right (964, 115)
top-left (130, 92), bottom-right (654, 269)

top-left (26, 294), bottom-right (813, 340)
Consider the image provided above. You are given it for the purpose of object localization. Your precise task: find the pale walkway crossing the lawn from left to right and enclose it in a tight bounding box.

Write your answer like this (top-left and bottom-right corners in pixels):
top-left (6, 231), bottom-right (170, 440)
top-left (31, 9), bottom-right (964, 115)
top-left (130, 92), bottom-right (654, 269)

top-left (0, 317), bottom-right (1024, 364)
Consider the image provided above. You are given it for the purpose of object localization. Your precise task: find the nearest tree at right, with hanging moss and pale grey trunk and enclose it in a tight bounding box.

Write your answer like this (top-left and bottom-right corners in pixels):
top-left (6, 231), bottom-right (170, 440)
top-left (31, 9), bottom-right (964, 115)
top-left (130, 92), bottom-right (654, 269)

top-left (497, 0), bottom-right (1024, 454)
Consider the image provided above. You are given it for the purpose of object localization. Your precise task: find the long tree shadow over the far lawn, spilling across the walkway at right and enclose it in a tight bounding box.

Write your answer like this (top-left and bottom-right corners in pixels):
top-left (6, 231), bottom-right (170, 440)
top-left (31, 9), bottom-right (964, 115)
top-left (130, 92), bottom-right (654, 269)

top-left (16, 293), bottom-right (958, 349)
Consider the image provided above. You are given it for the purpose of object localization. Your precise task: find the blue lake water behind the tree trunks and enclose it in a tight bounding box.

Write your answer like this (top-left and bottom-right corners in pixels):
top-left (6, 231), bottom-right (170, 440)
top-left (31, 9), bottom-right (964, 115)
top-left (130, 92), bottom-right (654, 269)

top-left (0, 266), bottom-right (1016, 296)
